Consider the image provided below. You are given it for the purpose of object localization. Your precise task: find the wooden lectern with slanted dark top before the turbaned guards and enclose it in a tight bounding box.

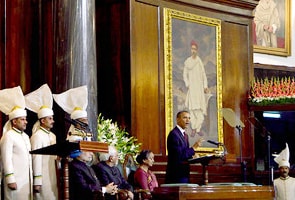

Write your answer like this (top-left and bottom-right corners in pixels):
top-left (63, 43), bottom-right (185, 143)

top-left (30, 140), bottom-right (109, 200)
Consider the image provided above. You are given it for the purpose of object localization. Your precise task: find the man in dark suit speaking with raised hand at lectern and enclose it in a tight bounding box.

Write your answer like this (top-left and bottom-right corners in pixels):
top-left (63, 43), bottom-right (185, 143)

top-left (165, 111), bottom-right (203, 183)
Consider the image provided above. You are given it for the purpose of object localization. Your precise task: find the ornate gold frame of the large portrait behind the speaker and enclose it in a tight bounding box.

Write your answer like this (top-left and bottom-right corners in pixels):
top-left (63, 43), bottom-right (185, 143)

top-left (164, 8), bottom-right (223, 155)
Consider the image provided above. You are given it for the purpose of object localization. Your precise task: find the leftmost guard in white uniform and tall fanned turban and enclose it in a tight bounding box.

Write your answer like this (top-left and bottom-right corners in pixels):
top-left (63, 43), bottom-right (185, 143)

top-left (0, 86), bottom-right (33, 200)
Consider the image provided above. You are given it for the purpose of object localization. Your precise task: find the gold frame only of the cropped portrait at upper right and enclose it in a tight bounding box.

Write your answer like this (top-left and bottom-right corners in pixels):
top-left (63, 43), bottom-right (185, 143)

top-left (253, 0), bottom-right (291, 56)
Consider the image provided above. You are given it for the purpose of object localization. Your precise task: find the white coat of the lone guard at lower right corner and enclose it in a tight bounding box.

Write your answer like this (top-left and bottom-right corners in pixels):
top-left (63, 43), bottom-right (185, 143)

top-left (274, 177), bottom-right (295, 200)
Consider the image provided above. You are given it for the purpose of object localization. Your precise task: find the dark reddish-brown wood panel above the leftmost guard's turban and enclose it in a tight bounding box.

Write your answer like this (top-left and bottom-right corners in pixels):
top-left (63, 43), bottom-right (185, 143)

top-left (2, 0), bottom-right (33, 91)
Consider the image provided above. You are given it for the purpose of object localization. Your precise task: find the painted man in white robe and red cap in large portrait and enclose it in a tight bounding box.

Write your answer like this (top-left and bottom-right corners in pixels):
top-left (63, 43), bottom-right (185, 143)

top-left (183, 41), bottom-right (209, 134)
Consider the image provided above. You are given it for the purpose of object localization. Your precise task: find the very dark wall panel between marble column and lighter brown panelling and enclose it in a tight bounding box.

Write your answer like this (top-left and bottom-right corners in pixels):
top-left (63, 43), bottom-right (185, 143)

top-left (96, 0), bottom-right (132, 129)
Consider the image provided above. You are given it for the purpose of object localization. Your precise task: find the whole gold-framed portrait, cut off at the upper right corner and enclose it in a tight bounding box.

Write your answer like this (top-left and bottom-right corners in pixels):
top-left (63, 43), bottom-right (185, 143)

top-left (253, 0), bottom-right (291, 56)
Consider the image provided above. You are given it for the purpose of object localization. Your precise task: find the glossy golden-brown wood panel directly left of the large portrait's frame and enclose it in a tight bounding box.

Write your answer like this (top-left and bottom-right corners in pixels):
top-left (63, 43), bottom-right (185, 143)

top-left (131, 2), bottom-right (164, 153)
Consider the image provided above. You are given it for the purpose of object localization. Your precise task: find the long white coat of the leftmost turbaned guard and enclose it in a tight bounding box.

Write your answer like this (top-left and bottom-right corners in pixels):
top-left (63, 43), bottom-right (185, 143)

top-left (0, 129), bottom-right (33, 200)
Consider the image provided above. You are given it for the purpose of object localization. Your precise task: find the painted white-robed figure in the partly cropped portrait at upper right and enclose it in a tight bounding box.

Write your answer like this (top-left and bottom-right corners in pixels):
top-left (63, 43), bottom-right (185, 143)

top-left (254, 0), bottom-right (280, 48)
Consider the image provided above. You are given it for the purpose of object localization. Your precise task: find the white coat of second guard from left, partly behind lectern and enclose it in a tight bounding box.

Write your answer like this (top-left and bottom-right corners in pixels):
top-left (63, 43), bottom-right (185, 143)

top-left (30, 128), bottom-right (58, 200)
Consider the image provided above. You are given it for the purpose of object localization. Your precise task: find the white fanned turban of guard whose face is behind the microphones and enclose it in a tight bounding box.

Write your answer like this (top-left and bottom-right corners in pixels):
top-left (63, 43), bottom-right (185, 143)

top-left (53, 85), bottom-right (88, 119)
